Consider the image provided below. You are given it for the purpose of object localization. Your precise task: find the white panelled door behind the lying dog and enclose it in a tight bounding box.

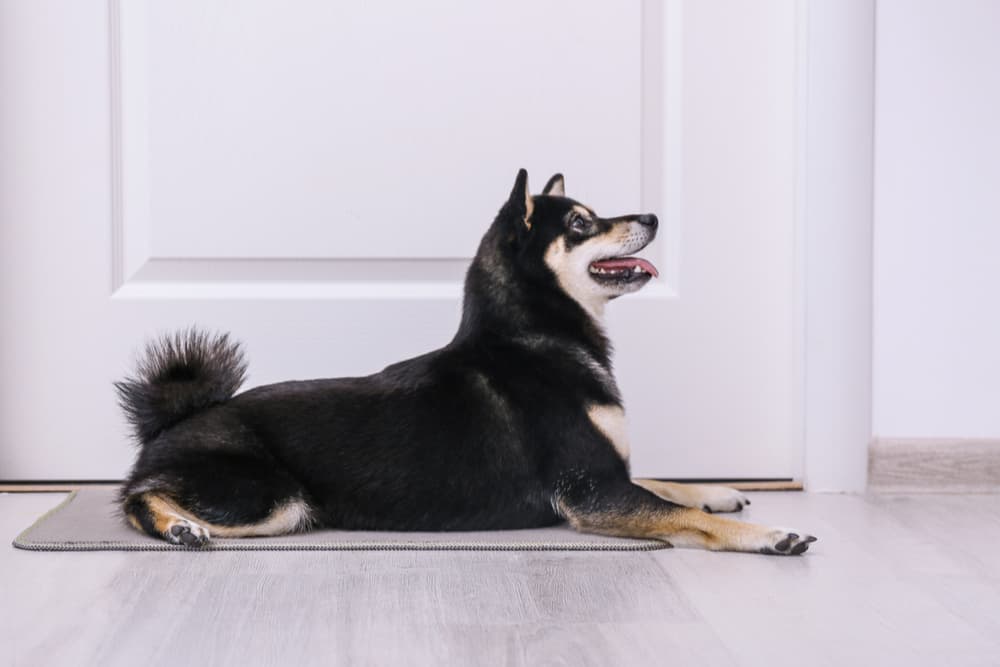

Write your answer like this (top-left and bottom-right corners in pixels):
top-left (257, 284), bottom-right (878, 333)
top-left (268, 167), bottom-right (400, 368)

top-left (0, 0), bottom-right (801, 480)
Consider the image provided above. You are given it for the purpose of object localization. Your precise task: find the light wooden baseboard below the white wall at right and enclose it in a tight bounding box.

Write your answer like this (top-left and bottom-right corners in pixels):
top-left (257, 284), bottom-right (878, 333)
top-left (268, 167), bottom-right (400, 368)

top-left (868, 438), bottom-right (1000, 493)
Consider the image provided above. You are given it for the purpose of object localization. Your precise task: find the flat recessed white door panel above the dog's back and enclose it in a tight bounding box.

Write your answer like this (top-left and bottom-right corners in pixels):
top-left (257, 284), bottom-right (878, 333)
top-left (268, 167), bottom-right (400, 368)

top-left (135, 0), bottom-right (641, 259)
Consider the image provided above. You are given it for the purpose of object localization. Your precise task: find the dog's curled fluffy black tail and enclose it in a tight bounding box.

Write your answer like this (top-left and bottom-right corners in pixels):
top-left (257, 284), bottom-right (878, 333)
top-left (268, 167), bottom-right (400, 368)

top-left (115, 329), bottom-right (247, 444)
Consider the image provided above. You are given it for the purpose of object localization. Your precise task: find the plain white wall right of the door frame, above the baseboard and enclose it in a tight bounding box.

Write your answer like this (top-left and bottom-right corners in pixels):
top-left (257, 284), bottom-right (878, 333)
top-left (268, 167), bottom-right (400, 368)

top-left (873, 0), bottom-right (1000, 438)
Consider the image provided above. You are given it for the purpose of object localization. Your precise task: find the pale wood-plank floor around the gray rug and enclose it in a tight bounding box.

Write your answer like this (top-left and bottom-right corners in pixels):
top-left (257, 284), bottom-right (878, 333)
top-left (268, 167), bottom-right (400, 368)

top-left (0, 493), bottom-right (1000, 667)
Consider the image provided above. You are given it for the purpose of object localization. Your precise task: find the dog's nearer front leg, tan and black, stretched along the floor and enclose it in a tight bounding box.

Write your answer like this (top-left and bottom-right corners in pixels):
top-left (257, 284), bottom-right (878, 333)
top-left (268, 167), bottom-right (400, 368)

top-left (554, 474), bottom-right (816, 555)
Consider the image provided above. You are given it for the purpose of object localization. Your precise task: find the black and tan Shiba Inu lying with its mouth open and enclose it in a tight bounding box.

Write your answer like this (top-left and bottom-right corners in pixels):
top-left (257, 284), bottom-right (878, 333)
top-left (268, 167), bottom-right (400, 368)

top-left (115, 169), bottom-right (816, 555)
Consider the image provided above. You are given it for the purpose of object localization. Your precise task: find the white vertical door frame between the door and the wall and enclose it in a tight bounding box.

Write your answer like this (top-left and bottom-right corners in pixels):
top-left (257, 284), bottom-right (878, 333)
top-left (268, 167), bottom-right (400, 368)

top-left (797, 0), bottom-right (875, 492)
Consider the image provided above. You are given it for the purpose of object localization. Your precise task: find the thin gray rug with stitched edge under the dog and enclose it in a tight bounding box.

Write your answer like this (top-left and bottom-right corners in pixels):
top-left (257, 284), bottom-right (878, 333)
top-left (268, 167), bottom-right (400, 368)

top-left (14, 488), bottom-right (666, 552)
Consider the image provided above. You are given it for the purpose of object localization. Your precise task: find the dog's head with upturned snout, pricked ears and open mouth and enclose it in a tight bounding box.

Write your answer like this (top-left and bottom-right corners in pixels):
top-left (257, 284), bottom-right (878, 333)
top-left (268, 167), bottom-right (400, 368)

top-left (497, 169), bottom-right (658, 316)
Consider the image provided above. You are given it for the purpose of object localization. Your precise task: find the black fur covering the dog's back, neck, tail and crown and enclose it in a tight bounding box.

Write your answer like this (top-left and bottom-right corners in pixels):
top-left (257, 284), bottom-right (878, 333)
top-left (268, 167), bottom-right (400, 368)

top-left (118, 170), bottom-right (662, 530)
